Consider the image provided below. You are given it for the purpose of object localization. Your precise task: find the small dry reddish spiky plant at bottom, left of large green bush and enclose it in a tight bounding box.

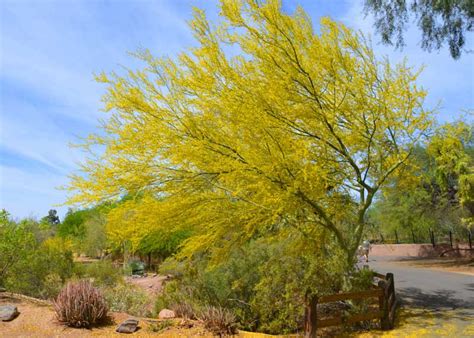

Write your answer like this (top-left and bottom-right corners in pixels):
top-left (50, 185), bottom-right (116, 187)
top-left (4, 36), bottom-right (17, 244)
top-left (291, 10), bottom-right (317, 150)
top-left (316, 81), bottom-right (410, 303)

top-left (199, 306), bottom-right (237, 336)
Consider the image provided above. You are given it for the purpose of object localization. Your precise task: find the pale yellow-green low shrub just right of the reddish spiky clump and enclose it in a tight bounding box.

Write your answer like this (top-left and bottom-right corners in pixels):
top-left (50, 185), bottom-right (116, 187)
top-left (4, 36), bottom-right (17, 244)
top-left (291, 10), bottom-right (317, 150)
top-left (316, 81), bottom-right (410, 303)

top-left (104, 284), bottom-right (153, 317)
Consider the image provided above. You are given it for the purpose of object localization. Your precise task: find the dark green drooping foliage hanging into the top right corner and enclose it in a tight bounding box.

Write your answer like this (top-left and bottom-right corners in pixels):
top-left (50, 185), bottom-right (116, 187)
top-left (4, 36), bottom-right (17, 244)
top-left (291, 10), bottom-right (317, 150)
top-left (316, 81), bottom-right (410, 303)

top-left (364, 0), bottom-right (474, 59)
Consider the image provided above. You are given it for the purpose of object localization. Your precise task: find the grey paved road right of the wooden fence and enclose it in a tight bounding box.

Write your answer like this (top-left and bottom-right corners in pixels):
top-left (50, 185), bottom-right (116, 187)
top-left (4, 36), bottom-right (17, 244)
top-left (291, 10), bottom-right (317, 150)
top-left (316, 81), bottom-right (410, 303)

top-left (369, 256), bottom-right (474, 314)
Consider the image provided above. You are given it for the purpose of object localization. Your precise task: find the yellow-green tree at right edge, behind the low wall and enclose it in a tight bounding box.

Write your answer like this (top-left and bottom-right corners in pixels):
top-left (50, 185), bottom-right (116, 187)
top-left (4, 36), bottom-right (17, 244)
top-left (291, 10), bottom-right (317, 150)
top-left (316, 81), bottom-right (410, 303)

top-left (370, 121), bottom-right (474, 242)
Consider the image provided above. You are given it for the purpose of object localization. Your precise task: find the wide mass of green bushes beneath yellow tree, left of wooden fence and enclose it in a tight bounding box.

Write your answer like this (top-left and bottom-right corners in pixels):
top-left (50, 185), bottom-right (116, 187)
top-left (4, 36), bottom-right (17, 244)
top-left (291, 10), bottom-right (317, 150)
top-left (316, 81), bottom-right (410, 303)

top-left (156, 234), bottom-right (345, 334)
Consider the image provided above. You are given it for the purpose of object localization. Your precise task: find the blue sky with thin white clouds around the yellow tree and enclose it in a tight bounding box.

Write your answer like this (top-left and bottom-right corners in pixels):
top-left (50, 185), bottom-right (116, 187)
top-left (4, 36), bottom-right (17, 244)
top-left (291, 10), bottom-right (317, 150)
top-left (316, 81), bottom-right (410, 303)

top-left (0, 0), bottom-right (474, 217)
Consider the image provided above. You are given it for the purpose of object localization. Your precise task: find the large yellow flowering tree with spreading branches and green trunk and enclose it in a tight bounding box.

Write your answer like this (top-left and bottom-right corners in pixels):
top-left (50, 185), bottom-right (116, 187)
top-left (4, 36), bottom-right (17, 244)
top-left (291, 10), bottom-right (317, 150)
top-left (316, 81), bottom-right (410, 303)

top-left (66, 0), bottom-right (432, 263)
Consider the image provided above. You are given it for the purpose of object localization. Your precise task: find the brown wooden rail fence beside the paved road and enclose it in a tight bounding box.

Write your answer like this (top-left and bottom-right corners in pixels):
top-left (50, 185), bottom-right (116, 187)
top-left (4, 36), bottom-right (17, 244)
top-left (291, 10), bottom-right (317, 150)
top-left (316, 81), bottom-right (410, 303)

top-left (305, 273), bottom-right (397, 338)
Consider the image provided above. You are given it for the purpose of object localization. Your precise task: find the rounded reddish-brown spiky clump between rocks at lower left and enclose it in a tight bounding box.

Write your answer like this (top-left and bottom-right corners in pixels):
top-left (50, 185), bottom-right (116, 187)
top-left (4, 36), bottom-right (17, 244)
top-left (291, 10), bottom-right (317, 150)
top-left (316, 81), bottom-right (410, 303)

top-left (54, 280), bottom-right (108, 328)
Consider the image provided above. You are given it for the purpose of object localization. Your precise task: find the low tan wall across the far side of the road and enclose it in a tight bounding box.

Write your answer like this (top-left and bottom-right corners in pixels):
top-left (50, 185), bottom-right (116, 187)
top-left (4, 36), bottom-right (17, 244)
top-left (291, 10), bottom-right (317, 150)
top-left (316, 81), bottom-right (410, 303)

top-left (370, 243), bottom-right (472, 257)
